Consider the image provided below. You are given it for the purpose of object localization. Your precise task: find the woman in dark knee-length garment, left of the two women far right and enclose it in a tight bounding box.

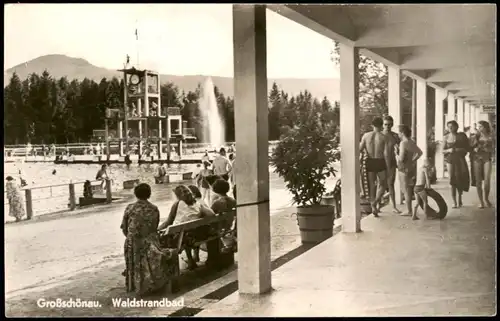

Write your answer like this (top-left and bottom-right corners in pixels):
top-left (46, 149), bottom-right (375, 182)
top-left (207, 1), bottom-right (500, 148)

top-left (443, 120), bottom-right (470, 208)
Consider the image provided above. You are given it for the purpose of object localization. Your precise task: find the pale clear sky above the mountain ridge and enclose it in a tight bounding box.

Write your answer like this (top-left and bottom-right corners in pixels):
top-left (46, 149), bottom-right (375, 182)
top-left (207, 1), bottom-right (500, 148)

top-left (4, 4), bottom-right (339, 78)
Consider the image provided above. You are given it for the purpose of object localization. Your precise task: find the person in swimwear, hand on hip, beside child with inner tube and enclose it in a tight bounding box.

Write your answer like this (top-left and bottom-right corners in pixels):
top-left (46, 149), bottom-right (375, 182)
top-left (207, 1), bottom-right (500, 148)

top-left (396, 125), bottom-right (423, 219)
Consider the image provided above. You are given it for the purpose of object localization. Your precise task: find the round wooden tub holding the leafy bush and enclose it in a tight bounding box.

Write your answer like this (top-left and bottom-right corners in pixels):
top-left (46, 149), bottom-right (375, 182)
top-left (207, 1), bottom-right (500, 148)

top-left (297, 205), bottom-right (335, 244)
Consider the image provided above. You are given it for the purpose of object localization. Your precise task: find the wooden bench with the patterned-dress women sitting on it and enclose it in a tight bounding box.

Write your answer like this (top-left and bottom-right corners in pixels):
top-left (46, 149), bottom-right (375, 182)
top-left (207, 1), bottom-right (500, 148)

top-left (158, 210), bottom-right (236, 293)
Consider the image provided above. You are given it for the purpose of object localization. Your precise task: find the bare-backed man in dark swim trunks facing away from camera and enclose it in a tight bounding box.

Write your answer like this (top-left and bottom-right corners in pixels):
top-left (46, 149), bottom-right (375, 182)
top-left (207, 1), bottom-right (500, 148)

top-left (359, 117), bottom-right (391, 217)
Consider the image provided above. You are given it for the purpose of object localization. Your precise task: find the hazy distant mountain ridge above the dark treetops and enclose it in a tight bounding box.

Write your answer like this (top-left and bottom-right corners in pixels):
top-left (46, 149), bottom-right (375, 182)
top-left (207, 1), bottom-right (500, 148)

top-left (4, 55), bottom-right (340, 101)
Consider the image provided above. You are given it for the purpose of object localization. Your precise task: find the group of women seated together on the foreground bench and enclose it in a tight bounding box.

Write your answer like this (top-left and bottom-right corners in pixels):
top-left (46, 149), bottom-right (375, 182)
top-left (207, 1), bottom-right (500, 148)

top-left (121, 171), bottom-right (236, 295)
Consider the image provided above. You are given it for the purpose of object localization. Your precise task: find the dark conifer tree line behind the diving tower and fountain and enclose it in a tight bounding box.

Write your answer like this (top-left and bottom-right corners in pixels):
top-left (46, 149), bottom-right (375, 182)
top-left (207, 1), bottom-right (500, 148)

top-left (4, 71), bottom-right (340, 144)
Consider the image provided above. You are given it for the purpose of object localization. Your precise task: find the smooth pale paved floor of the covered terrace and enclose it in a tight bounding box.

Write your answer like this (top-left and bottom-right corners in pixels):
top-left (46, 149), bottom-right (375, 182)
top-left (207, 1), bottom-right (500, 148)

top-left (196, 176), bottom-right (497, 317)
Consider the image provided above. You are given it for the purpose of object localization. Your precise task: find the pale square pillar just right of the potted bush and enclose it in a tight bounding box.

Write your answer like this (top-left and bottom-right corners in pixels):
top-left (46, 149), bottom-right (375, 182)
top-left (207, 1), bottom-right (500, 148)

top-left (339, 43), bottom-right (361, 233)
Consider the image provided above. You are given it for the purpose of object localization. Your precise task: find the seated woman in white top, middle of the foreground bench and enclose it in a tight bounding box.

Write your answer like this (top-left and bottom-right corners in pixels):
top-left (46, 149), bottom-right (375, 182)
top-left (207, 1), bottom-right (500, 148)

top-left (158, 185), bottom-right (215, 269)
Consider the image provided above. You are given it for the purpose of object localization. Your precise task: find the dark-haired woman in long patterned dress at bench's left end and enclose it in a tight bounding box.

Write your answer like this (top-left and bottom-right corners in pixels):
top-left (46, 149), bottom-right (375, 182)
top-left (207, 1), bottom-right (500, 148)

top-left (120, 183), bottom-right (175, 296)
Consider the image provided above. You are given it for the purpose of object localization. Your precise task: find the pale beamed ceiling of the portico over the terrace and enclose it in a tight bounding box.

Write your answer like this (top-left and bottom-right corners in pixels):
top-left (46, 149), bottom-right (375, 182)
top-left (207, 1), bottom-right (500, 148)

top-left (268, 4), bottom-right (496, 105)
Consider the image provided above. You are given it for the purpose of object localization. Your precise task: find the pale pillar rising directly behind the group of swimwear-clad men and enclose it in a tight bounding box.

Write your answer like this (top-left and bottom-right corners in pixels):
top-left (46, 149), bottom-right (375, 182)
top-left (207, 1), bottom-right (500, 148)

top-left (388, 66), bottom-right (402, 204)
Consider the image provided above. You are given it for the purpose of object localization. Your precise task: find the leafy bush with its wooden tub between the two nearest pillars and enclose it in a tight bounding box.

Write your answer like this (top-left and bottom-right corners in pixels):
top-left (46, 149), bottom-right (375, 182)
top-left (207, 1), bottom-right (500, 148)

top-left (271, 101), bottom-right (339, 243)
